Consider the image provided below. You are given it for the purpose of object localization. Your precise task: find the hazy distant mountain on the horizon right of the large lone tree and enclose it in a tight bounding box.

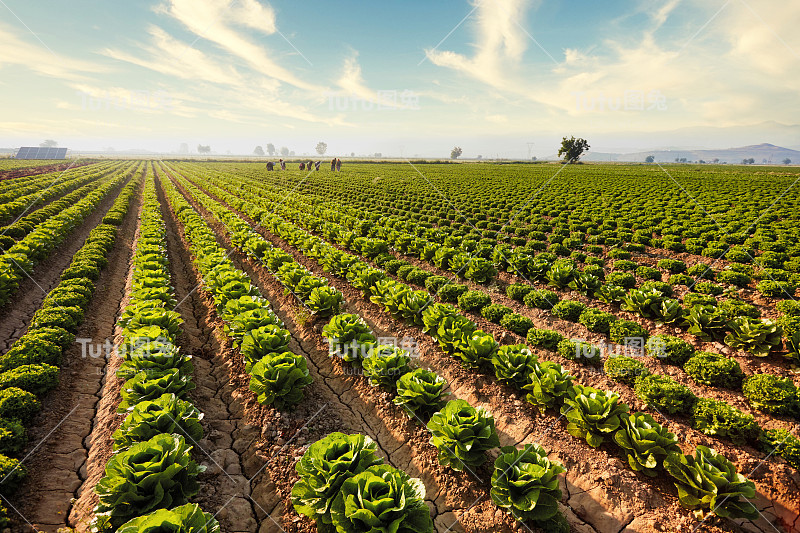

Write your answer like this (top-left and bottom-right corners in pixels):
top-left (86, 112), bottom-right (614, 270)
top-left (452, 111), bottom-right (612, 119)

top-left (582, 143), bottom-right (800, 165)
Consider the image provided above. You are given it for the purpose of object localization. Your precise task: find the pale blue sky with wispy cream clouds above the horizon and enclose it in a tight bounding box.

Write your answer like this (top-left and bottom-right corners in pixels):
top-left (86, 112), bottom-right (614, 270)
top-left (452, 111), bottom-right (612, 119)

top-left (0, 0), bottom-right (800, 157)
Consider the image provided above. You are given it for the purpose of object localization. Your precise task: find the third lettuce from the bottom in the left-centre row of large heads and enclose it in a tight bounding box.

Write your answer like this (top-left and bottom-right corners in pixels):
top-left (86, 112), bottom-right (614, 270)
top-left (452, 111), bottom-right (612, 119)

top-left (113, 394), bottom-right (203, 452)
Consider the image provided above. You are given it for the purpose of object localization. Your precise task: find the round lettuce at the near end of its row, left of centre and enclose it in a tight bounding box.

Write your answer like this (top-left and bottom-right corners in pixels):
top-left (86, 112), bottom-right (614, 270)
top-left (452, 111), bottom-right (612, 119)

top-left (250, 352), bottom-right (314, 410)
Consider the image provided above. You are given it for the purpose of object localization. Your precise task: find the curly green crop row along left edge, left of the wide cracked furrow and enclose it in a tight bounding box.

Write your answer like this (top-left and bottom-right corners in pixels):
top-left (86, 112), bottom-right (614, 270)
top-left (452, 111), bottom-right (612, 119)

top-left (0, 168), bottom-right (141, 525)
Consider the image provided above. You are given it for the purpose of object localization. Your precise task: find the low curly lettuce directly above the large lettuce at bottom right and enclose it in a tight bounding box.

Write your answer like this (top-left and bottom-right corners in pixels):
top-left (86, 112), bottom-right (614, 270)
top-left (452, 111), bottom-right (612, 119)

top-left (692, 398), bottom-right (761, 445)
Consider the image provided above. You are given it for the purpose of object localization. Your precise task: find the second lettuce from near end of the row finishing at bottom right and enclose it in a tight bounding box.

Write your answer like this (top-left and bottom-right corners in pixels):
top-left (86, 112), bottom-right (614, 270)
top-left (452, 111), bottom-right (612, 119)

top-left (614, 413), bottom-right (681, 477)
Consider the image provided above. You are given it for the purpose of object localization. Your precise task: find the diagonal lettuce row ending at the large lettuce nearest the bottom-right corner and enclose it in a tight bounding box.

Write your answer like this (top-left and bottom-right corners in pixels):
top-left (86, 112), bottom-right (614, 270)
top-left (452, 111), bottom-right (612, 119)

top-left (172, 164), bottom-right (772, 518)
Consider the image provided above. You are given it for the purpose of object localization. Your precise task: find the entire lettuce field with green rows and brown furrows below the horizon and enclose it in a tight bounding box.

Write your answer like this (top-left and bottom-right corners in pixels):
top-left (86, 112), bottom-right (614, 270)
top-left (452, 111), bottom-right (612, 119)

top-left (0, 160), bottom-right (800, 533)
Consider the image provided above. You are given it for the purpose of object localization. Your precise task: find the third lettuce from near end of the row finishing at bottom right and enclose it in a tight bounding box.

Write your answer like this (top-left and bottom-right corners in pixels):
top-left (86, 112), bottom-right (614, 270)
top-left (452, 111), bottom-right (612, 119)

top-left (561, 385), bottom-right (628, 448)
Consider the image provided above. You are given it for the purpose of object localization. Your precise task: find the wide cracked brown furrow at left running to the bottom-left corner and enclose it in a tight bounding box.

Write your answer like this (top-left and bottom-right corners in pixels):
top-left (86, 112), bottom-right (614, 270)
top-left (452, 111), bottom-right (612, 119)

top-left (11, 172), bottom-right (141, 532)
